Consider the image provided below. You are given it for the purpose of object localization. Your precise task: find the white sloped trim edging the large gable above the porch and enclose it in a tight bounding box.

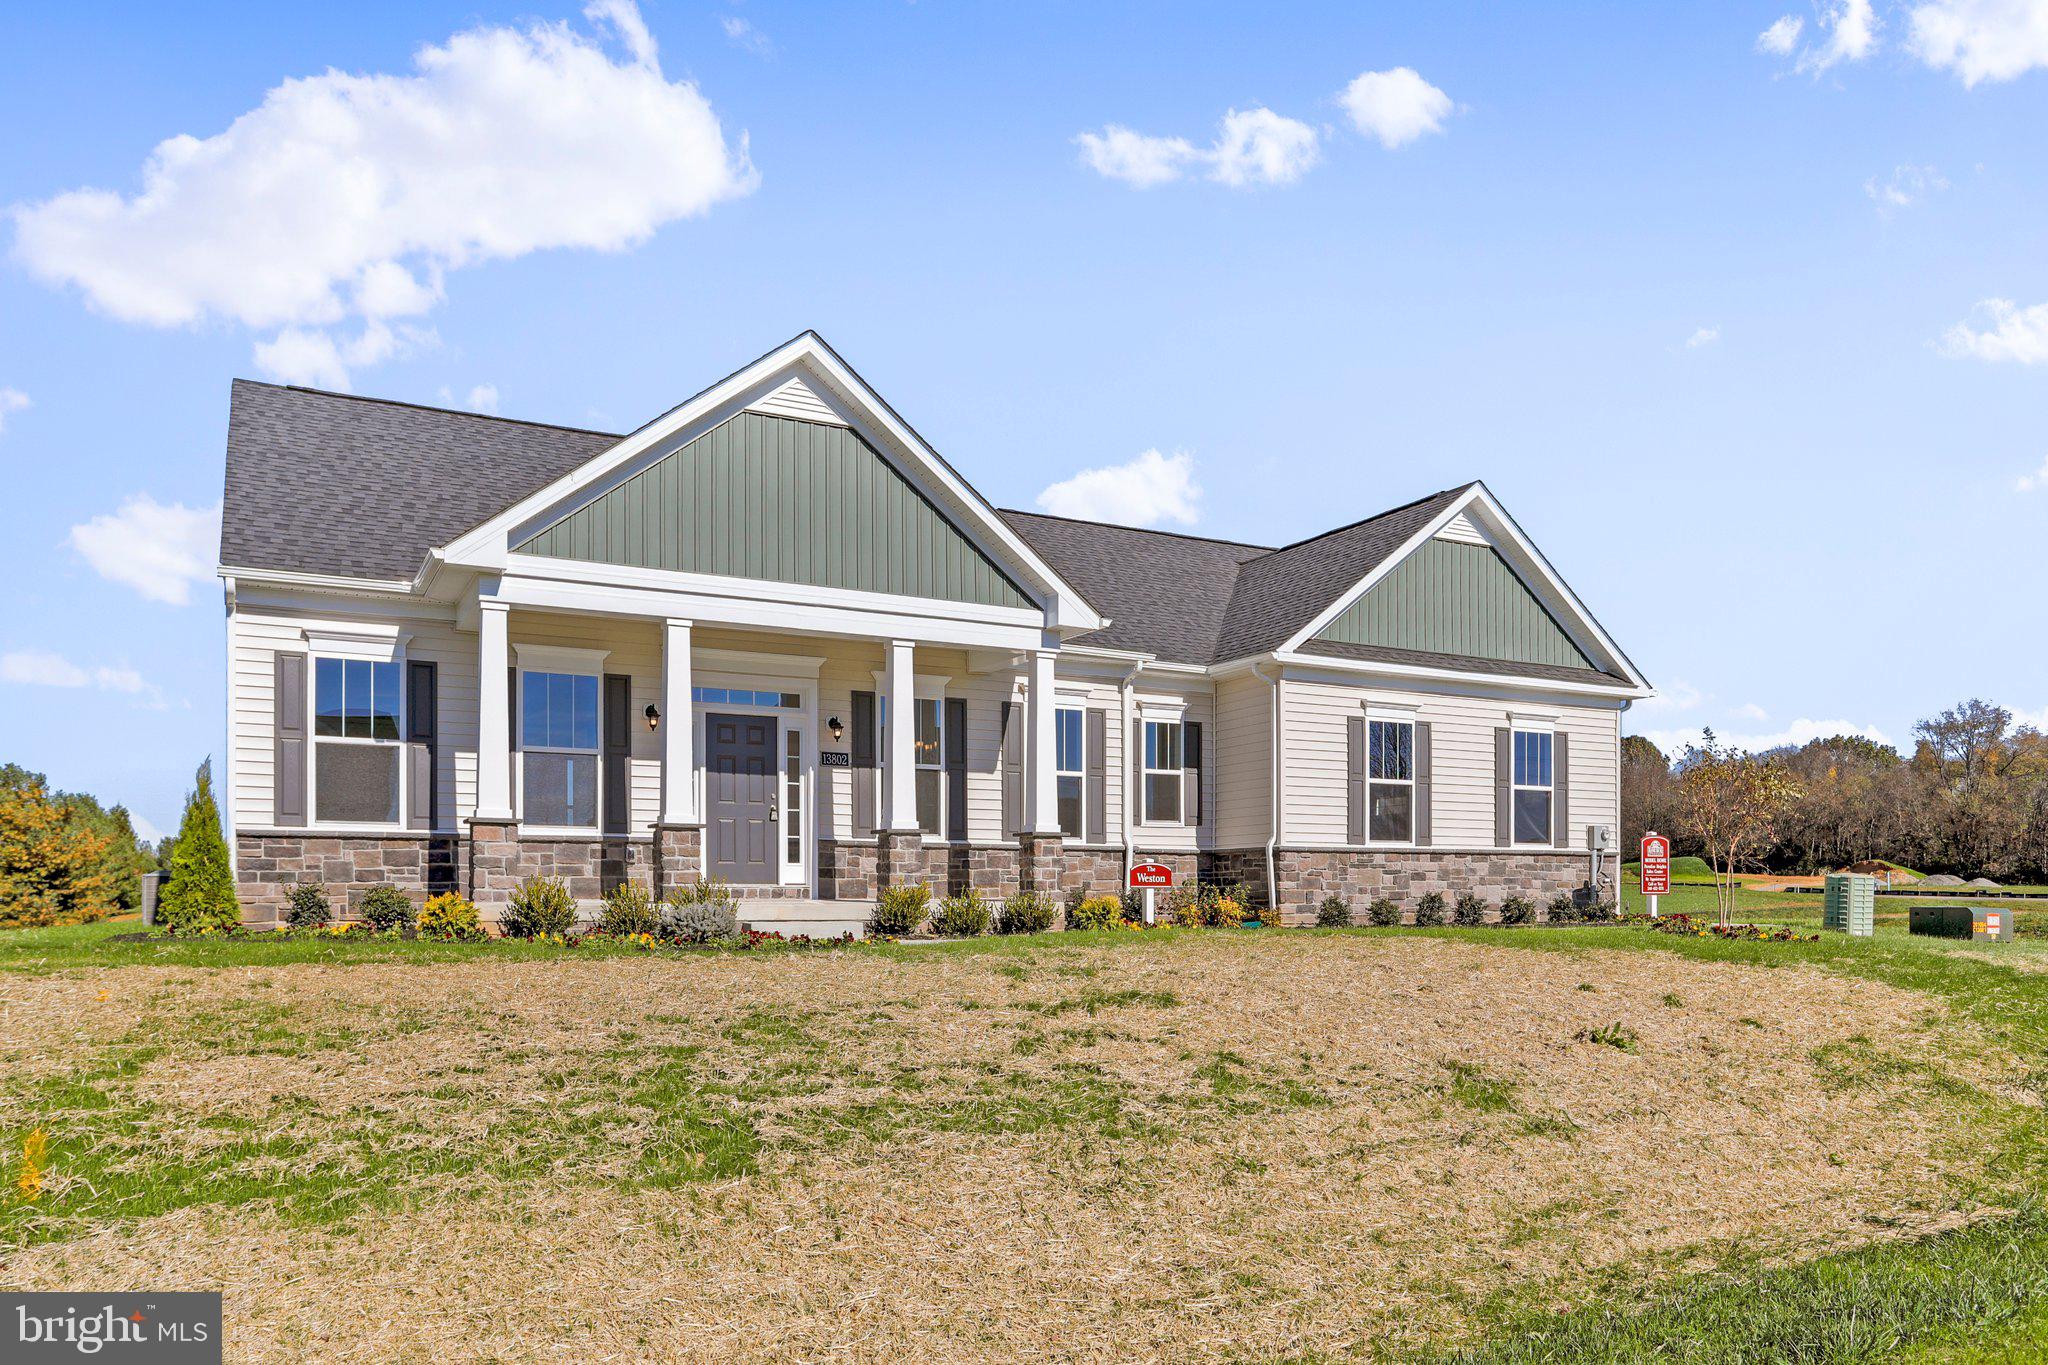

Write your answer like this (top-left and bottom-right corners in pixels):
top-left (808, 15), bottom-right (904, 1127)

top-left (428, 332), bottom-right (1106, 632)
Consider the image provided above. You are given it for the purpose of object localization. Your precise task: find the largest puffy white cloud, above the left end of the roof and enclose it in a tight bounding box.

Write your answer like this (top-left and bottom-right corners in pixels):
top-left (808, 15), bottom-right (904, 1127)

top-left (12, 0), bottom-right (758, 387)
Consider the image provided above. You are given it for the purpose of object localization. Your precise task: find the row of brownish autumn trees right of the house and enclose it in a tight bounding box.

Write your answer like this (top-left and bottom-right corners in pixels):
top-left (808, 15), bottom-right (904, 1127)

top-left (1622, 698), bottom-right (2048, 882)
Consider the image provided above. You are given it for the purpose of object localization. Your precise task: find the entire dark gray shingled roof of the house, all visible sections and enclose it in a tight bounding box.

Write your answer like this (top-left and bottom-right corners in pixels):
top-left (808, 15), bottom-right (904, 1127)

top-left (221, 379), bottom-right (1610, 679)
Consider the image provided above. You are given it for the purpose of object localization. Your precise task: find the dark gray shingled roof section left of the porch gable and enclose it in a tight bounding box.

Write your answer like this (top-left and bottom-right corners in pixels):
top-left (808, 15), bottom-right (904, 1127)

top-left (221, 379), bottom-right (618, 579)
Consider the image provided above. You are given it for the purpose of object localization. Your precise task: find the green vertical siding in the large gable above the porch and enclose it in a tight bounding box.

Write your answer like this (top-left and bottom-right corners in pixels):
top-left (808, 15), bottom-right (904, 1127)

top-left (514, 411), bottom-right (1032, 608)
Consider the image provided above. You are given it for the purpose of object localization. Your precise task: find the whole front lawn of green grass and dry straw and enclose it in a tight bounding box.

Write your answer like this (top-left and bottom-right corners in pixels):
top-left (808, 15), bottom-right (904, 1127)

top-left (0, 912), bottom-right (2048, 1361)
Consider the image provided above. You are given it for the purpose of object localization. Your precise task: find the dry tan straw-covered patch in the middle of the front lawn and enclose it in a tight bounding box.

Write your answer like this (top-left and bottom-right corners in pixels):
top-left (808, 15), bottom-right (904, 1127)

top-left (0, 933), bottom-right (2007, 1361)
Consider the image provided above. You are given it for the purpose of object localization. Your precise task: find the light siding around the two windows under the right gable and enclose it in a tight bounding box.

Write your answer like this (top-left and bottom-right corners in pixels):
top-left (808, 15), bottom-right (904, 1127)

top-left (1282, 679), bottom-right (1620, 849)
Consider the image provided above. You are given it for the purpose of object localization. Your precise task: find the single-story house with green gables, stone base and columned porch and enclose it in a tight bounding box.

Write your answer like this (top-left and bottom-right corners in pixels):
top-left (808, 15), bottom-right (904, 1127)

top-left (219, 332), bottom-right (1651, 923)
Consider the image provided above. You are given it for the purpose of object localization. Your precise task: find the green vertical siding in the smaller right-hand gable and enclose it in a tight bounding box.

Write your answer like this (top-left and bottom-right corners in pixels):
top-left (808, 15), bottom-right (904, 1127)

top-left (1315, 540), bottom-right (1597, 669)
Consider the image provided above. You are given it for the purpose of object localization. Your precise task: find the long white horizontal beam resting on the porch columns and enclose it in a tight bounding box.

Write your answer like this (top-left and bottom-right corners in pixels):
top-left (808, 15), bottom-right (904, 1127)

top-left (487, 575), bottom-right (1042, 649)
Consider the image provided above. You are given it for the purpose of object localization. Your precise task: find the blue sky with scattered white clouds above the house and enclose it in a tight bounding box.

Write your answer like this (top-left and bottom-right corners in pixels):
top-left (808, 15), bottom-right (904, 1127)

top-left (0, 0), bottom-right (2048, 829)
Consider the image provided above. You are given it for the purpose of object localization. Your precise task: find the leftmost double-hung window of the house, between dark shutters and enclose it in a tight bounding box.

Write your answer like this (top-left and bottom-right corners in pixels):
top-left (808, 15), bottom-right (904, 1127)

top-left (313, 659), bottom-right (403, 825)
